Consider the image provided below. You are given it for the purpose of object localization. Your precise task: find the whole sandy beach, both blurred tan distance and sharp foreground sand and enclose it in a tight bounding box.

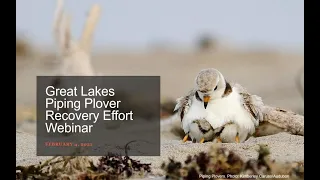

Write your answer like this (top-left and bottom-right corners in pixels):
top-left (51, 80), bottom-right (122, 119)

top-left (16, 47), bottom-right (304, 179)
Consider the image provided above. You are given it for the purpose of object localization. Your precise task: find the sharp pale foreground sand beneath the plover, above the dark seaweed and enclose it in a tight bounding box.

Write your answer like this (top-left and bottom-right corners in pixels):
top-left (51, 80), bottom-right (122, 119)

top-left (16, 120), bottom-right (304, 176)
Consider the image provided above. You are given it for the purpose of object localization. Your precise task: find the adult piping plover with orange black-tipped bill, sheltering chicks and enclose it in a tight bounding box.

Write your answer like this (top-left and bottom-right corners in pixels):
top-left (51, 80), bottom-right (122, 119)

top-left (175, 68), bottom-right (263, 142)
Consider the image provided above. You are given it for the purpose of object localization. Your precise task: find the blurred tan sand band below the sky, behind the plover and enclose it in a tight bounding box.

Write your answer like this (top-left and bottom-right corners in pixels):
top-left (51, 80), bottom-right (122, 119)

top-left (16, 42), bottom-right (304, 114)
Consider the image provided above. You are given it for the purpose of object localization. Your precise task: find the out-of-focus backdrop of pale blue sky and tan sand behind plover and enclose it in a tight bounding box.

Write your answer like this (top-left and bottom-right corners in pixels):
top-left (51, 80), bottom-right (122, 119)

top-left (16, 0), bottom-right (304, 118)
